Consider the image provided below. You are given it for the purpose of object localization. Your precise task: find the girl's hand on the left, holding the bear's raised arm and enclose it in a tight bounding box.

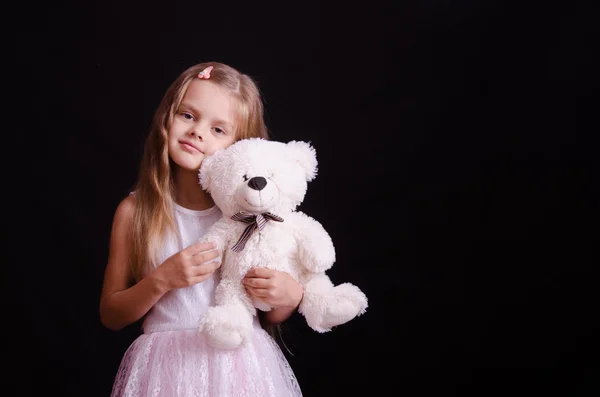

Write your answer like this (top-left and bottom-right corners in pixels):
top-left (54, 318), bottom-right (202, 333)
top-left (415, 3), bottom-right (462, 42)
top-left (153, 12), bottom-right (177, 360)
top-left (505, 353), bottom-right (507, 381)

top-left (150, 238), bottom-right (221, 292)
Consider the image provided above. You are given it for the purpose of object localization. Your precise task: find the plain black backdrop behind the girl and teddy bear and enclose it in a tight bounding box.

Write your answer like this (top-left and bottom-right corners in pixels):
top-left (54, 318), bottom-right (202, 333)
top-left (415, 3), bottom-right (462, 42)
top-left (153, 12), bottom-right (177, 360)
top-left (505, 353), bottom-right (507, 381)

top-left (7, 0), bottom-right (600, 396)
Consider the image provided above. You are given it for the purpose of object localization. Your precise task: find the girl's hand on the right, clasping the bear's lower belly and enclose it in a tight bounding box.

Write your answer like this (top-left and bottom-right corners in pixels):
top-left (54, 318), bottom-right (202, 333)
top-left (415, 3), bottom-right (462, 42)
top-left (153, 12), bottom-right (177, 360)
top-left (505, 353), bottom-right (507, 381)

top-left (242, 267), bottom-right (304, 309)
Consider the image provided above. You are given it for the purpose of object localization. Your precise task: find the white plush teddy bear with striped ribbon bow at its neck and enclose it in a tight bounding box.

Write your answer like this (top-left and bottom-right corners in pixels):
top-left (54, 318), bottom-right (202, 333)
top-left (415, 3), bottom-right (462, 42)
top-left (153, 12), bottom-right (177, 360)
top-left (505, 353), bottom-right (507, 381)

top-left (199, 138), bottom-right (368, 349)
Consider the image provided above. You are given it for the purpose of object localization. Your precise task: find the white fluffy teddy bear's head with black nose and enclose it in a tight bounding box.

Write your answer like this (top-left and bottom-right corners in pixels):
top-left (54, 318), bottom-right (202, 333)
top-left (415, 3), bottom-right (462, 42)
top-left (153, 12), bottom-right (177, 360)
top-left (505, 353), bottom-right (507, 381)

top-left (199, 138), bottom-right (317, 217)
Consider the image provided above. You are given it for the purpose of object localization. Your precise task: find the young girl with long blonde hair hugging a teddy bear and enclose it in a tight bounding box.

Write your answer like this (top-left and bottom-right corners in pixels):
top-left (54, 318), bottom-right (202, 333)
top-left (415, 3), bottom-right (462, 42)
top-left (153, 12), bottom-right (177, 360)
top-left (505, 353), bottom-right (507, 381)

top-left (100, 62), bottom-right (303, 397)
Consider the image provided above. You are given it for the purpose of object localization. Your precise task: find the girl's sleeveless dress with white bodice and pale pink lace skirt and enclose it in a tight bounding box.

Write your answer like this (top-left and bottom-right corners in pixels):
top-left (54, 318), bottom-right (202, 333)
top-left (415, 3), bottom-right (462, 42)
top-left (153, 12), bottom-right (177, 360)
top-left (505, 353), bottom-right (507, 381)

top-left (111, 204), bottom-right (302, 397)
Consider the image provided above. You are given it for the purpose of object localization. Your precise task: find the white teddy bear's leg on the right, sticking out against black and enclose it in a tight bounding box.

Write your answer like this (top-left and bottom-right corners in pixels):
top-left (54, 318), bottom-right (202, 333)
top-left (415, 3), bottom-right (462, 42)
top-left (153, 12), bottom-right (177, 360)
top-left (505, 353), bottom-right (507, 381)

top-left (299, 273), bottom-right (368, 332)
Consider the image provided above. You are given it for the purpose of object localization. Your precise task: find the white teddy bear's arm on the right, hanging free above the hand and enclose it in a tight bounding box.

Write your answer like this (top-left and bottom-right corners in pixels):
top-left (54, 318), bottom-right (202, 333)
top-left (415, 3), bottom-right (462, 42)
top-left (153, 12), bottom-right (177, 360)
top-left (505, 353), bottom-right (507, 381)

top-left (293, 212), bottom-right (335, 273)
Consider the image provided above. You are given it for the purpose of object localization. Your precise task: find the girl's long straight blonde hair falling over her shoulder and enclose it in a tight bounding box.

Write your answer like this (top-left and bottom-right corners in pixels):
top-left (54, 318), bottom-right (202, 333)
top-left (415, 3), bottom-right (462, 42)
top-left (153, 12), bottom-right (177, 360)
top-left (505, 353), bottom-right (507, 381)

top-left (130, 62), bottom-right (268, 281)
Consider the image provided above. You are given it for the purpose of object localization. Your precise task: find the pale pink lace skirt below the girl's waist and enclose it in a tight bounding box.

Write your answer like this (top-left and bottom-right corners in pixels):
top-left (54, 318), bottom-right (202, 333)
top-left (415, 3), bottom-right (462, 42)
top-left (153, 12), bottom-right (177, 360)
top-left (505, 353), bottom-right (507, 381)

top-left (111, 328), bottom-right (302, 397)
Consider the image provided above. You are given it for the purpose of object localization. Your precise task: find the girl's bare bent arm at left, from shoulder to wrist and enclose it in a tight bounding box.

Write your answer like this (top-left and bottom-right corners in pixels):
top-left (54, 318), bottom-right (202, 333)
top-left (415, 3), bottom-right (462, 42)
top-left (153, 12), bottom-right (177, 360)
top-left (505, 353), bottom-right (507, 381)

top-left (100, 196), bottom-right (167, 331)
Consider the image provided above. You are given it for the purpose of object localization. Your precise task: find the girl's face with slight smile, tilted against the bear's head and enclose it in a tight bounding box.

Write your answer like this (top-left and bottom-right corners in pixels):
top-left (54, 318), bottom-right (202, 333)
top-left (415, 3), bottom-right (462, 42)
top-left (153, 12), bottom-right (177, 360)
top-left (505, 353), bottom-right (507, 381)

top-left (168, 79), bottom-right (235, 172)
